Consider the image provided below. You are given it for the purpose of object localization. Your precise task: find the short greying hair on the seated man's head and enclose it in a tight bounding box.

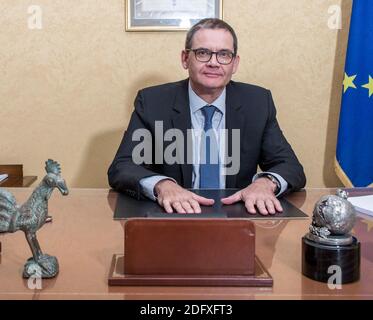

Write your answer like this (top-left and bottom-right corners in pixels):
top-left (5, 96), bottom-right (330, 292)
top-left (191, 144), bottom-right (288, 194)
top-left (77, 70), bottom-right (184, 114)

top-left (185, 18), bottom-right (238, 55)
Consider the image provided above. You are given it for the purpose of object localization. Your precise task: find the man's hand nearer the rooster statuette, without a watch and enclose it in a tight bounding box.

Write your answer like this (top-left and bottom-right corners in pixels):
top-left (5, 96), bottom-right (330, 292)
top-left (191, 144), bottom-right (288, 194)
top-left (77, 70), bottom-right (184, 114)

top-left (154, 180), bottom-right (214, 213)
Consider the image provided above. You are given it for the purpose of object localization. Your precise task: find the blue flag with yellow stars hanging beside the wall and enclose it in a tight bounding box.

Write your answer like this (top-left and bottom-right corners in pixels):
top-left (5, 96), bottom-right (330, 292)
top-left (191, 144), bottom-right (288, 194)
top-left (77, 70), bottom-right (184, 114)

top-left (335, 0), bottom-right (373, 187)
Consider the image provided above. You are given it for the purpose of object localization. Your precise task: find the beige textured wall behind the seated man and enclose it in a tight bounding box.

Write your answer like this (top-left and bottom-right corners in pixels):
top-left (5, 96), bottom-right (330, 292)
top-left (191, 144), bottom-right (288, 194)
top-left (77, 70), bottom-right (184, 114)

top-left (0, 0), bottom-right (351, 187)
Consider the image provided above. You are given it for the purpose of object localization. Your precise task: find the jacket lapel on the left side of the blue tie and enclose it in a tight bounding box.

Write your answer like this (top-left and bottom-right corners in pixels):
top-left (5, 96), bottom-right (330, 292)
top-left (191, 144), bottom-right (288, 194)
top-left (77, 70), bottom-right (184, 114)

top-left (171, 79), bottom-right (193, 188)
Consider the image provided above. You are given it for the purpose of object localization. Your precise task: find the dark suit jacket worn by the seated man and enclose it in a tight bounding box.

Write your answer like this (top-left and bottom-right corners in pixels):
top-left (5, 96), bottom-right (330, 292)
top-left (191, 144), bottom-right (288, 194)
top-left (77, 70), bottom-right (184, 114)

top-left (108, 79), bottom-right (306, 198)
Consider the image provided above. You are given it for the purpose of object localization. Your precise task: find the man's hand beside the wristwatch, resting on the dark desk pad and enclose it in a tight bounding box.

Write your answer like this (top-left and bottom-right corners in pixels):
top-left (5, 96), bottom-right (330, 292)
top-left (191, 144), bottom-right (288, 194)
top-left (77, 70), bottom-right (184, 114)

top-left (221, 178), bottom-right (282, 215)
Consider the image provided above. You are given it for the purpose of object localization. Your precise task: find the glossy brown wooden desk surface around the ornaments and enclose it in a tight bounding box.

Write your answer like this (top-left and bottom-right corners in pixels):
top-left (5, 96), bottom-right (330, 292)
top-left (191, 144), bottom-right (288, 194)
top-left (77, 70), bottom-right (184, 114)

top-left (0, 188), bottom-right (373, 300)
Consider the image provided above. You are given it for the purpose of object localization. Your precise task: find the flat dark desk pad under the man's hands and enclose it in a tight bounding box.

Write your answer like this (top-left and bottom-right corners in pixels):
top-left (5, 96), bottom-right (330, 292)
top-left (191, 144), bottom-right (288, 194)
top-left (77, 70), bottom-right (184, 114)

top-left (114, 189), bottom-right (308, 220)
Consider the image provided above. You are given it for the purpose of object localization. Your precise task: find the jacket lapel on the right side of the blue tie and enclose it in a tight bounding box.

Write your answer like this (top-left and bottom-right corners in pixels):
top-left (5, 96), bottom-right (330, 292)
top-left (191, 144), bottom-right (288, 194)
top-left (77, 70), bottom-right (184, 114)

top-left (225, 81), bottom-right (244, 188)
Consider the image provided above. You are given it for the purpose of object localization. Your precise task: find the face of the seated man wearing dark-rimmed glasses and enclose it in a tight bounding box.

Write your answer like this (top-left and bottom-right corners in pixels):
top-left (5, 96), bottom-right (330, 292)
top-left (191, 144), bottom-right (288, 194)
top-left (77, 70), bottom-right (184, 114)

top-left (181, 29), bottom-right (239, 94)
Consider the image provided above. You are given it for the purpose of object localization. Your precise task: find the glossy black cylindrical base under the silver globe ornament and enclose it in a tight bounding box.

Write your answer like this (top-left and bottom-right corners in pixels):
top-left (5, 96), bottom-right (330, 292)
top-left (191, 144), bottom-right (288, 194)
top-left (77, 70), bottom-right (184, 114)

top-left (302, 237), bottom-right (360, 284)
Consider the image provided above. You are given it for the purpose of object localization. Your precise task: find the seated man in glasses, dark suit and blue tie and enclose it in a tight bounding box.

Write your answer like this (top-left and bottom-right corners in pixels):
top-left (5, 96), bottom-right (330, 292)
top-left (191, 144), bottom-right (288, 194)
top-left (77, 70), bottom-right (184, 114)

top-left (108, 19), bottom-right (306, 215)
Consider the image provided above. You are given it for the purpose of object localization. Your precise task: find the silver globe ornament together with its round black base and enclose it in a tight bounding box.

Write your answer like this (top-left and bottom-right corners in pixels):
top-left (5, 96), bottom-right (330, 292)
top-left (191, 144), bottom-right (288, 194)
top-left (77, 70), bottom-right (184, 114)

top-left (302, 189), bottom-right (361, 284)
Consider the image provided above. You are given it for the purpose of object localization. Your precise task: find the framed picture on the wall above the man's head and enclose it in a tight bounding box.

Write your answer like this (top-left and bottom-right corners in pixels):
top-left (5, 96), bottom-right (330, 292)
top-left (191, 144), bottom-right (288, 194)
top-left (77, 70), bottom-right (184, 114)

top-left (126, 0), bottom-right (223, 31)
